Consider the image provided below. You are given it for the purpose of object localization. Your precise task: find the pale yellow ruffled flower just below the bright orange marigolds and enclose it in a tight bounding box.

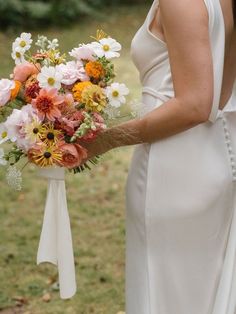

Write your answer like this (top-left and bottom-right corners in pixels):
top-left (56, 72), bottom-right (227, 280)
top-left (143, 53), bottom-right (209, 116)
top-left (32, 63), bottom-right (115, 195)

top-left (81, 84), bottom-right (107, 112)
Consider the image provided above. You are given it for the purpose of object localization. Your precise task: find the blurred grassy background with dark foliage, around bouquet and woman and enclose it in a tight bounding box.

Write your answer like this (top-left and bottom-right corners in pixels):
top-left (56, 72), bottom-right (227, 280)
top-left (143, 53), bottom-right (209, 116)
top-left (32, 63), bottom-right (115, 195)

top-left (0, 0), bottom-right (152, 314)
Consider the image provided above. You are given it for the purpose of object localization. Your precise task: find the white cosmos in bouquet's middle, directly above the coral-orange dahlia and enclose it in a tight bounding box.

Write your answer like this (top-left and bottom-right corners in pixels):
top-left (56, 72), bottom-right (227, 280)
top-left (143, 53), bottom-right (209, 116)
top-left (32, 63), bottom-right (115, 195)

top-left (37, 66), bottom-right (63, 89)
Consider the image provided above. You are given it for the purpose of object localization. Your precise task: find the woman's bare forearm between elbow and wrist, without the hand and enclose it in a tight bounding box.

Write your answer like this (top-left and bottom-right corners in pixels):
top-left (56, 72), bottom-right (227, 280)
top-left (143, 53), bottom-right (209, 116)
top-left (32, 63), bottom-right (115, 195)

top-left (106, 98), bottom-right (208, 149)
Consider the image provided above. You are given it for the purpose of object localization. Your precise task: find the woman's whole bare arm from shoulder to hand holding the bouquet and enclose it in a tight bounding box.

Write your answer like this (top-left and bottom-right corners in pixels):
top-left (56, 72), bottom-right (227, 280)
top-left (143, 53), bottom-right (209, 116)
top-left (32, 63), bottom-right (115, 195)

top-left (82, 0), bottom-right (213, 156)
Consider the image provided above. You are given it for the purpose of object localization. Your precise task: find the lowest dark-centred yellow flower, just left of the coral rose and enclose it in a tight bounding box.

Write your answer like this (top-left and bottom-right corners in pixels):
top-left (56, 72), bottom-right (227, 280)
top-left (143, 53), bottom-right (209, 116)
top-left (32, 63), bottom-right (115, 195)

top-left (28, 144), bottom-right (62, 168)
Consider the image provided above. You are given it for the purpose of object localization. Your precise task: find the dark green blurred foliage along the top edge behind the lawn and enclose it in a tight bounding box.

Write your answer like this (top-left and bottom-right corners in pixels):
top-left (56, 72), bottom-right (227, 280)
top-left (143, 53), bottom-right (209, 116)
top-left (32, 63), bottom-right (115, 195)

top-left (0, 0), bottom-right (151, 29)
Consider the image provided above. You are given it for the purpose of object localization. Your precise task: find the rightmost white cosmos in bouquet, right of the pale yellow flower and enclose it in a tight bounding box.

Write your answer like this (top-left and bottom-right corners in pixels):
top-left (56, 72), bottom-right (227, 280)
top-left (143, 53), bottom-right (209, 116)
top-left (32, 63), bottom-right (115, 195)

top-left (105, 83), bottom-right (129, 108)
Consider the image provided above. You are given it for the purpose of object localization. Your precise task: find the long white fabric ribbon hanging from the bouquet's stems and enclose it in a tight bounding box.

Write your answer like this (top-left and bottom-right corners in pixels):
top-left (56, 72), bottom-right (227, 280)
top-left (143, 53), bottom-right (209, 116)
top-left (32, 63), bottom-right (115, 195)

top-left (37, 167), bottom-right (76, 299)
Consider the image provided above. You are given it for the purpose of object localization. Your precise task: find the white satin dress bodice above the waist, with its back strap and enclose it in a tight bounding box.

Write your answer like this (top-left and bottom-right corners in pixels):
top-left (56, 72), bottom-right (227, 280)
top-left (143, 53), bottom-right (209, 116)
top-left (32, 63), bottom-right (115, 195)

top-left (131, 0), bottom-right (233, 122)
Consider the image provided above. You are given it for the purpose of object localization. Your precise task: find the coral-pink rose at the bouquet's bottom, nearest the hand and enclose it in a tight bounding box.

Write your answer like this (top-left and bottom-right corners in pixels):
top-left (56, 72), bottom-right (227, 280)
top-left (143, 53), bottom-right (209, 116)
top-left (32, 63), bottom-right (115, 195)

top-left (60, 144), bottom-right (87, 169)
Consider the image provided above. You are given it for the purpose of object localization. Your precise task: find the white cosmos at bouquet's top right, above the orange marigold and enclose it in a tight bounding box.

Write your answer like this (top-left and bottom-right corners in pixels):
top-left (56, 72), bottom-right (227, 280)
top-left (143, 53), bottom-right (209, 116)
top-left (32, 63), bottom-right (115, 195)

top-left (90, 37), bottom-right (121, 59)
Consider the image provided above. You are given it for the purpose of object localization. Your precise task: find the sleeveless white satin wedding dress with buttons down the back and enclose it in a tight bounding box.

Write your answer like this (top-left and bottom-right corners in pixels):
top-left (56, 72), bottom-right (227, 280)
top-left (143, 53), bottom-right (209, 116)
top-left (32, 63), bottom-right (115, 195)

top-left (126, 0), bottom-right (236, 314)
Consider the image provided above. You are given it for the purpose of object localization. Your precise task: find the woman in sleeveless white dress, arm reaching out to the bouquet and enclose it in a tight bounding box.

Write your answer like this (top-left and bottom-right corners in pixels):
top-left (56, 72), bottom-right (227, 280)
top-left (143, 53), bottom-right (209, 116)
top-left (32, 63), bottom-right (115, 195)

top-left (82, 0), bottom-right (236, 314)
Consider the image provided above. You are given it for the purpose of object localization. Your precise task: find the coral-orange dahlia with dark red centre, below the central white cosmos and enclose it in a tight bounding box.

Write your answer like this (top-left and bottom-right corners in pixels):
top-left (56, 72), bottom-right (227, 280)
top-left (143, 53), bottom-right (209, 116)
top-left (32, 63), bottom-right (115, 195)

top-left (32, 88), bottom-right (64, 121)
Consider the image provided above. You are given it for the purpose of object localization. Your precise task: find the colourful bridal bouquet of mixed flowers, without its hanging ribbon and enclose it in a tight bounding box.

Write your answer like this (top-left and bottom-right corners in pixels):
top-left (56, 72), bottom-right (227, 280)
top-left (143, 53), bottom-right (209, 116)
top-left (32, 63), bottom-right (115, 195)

top-left (0, 31), bottom-right (129, 189)
